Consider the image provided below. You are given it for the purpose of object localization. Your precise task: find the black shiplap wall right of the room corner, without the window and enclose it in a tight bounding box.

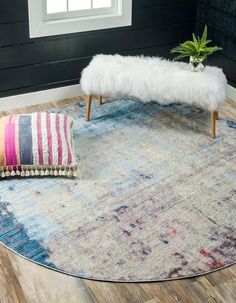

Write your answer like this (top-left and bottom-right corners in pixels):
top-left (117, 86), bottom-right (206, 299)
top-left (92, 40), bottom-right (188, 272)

top-left (196, 0), bottom-right (236, 87)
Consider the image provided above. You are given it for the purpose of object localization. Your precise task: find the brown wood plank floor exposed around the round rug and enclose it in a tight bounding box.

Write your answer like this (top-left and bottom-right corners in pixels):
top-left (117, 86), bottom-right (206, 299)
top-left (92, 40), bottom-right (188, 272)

top-left (0, 101), bottom-right (236, 303)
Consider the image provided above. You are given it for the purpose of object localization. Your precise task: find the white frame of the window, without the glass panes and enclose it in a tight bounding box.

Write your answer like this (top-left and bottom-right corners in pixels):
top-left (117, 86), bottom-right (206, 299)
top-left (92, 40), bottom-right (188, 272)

top-left (28, 0), bottom-right (132, 38)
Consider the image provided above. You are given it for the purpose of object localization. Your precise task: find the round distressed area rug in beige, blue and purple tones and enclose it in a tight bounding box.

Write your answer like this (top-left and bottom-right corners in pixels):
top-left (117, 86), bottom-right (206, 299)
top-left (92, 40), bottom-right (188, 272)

top-left (0, 100), bottom-right (236, 282)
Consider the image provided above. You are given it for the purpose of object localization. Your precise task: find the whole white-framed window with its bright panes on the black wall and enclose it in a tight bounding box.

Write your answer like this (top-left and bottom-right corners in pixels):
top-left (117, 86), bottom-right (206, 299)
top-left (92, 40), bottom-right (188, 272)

top-left (28, 0), bottom-right (132, 38)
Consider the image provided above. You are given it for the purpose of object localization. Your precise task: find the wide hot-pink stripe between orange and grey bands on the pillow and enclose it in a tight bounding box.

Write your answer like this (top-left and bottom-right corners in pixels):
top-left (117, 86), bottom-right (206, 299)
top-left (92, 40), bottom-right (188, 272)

top-left (5, 115), bottom-right (17, 165)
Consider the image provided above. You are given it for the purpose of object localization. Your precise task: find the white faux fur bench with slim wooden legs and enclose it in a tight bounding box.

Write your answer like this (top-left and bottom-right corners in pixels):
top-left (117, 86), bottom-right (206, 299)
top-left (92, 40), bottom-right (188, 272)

top-left (81, 55), bottom-right (227, 138)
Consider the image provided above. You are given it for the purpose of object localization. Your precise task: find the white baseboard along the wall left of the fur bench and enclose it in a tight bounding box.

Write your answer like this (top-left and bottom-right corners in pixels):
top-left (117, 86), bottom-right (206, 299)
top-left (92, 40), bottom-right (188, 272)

top-left (0, 84), bottom-right (83, 111)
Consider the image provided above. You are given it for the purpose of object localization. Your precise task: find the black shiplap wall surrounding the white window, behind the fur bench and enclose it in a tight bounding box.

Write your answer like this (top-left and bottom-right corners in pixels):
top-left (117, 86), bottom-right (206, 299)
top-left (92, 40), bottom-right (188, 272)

top-left (0, 0), bottom-right (196, 97)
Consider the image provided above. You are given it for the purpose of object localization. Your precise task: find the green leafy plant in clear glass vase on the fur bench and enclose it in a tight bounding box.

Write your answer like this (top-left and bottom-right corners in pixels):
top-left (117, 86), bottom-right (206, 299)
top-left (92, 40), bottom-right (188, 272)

top-left (171, 25), bottom-right (222, 72)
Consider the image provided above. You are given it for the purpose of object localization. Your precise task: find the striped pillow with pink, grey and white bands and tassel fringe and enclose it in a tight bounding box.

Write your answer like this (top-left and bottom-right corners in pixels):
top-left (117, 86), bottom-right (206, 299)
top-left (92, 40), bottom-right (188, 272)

top-left (0, 112), bottom-right (77, 178)
